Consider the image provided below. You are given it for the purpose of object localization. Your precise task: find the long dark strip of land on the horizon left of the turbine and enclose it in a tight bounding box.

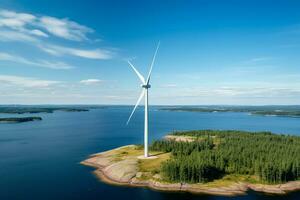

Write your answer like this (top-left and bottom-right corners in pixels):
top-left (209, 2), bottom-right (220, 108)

top-left (0, 105), bottom-right (103, 114)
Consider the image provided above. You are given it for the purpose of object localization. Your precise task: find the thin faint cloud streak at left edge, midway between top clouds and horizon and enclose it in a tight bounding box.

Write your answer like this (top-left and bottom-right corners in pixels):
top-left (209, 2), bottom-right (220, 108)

top-left (0, 52), bottom-right (73, 69)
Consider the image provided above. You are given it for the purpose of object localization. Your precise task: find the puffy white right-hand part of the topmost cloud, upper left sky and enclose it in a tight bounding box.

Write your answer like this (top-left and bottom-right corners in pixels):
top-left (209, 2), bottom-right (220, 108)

top-left (39, 16), bottom-right (93, 41)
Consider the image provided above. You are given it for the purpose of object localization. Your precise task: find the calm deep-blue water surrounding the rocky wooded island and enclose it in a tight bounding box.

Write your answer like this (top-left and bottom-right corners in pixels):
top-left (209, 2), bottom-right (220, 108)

top-left (0, 106), bottom-right (300, 200)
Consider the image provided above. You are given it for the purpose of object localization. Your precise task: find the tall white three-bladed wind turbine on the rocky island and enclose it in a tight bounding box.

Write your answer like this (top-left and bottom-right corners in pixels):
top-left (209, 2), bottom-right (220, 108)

top-left (126, 42), bottom-right (160, 158)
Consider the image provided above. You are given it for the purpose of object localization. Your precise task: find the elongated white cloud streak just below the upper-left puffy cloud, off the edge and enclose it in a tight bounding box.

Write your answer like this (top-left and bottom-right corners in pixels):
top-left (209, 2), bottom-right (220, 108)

top-left (39, 45), bottom-right (112, 59)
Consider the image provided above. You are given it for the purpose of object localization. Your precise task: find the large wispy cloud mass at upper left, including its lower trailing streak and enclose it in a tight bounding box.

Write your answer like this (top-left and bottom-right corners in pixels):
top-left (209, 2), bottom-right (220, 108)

top-left (0, 9), bottom-right (113, 59)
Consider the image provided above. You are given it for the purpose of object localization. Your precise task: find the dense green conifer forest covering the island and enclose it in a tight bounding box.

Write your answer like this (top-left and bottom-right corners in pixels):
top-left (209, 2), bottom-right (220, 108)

top-left (151, 130), bottom-right (300, 184)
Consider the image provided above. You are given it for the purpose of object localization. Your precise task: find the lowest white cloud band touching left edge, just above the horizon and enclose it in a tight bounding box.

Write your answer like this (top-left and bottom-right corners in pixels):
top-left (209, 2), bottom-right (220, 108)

top-left (0, 75), bottom-right (59, 88)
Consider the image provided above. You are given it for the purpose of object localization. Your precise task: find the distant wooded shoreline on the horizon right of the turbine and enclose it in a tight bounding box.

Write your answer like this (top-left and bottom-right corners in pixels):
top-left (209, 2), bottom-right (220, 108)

top-left (160, 106), bottom-right (300, 117)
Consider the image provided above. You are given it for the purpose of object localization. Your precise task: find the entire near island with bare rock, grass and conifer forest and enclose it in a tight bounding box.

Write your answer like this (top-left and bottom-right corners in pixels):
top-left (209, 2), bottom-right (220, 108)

top-left (82, 130), bottom-right (300, 196)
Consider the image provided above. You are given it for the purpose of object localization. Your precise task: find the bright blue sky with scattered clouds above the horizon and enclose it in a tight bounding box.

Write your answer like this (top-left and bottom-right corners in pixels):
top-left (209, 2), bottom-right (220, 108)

top-left (0, 0), bottom-right (300, 105)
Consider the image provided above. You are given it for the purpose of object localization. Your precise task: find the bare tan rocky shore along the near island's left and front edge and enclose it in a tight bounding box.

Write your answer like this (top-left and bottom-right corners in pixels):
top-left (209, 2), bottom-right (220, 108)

top-left (81, 145), bottom-right (300, 196)
